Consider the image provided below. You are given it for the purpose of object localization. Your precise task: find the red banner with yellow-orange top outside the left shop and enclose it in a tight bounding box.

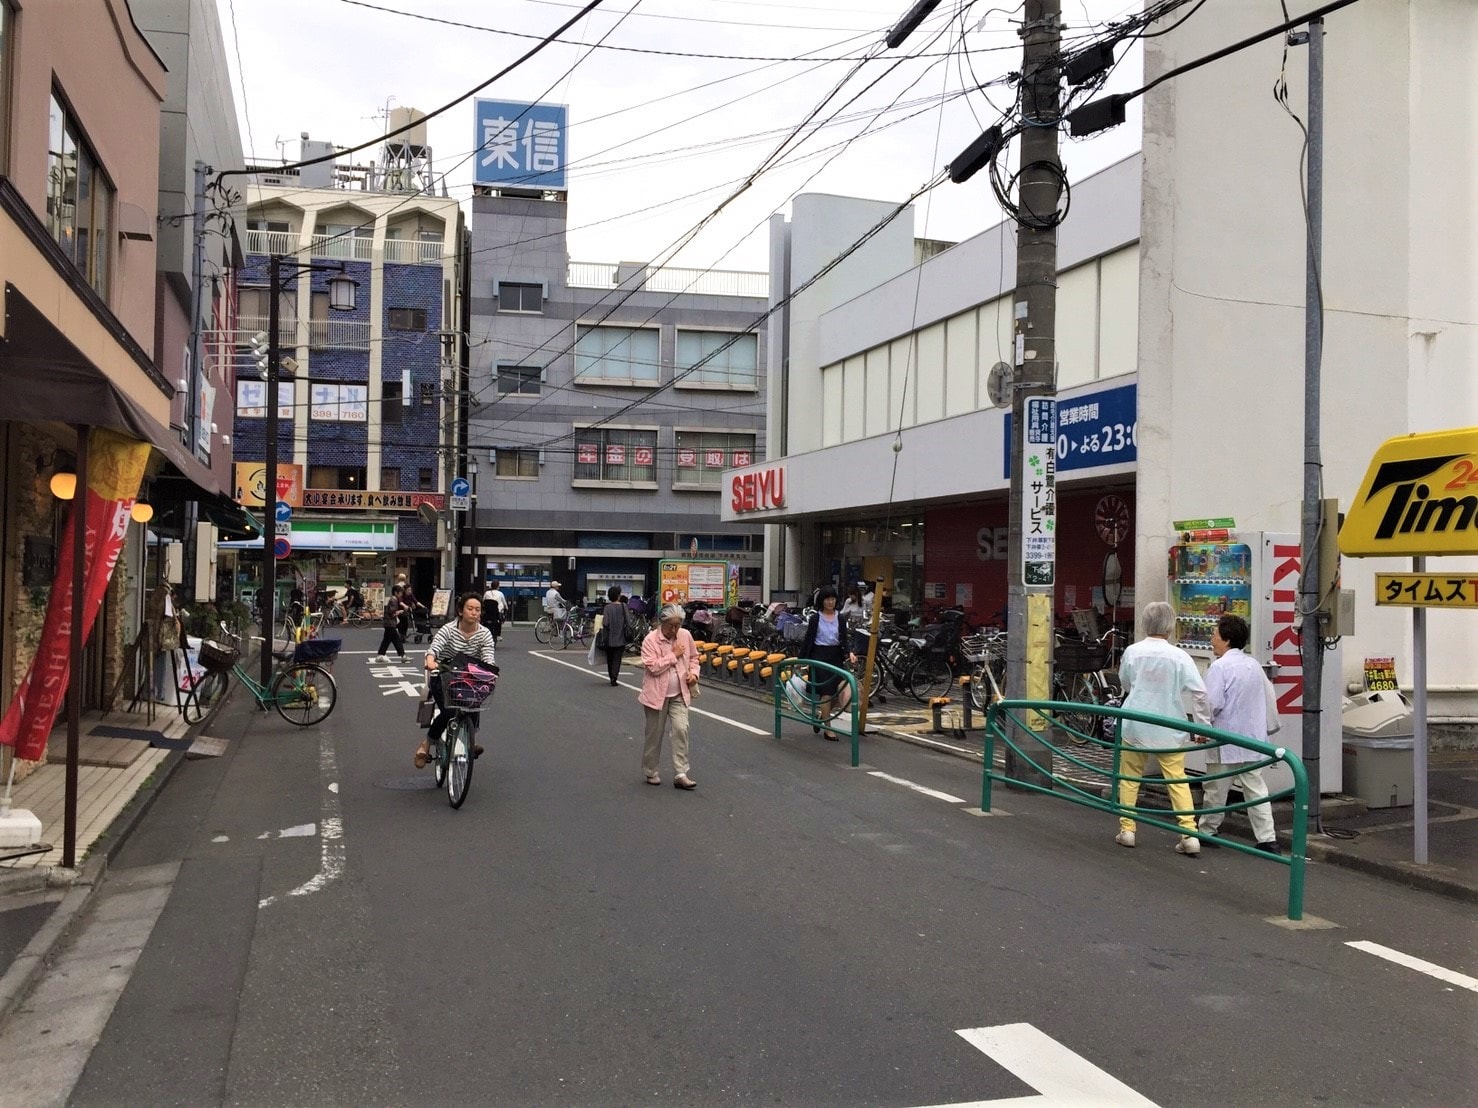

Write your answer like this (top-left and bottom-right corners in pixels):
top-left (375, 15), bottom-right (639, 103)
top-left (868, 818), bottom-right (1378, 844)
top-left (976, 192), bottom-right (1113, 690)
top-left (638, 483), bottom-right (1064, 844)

top-left (0, 427), bottom-right (149, 762)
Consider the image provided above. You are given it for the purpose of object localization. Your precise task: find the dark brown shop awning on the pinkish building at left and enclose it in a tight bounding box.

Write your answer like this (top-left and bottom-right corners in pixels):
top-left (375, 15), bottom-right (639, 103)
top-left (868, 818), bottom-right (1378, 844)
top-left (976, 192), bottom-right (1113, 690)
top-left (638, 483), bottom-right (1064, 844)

top-left (0, 282), bottom-right (229, 495)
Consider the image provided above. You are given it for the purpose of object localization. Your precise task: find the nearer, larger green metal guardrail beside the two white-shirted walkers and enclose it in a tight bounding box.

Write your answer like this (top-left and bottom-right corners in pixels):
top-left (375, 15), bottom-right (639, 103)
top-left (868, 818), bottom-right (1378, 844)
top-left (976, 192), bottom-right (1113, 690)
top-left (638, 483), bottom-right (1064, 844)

top-left (980, 700), bottom-right (1308, 919)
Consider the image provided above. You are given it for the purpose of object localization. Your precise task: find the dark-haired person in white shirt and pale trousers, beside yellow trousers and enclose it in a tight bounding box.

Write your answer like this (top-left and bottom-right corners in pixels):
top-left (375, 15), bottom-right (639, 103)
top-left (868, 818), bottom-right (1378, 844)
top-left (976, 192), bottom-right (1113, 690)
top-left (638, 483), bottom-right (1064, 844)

top-left (1199, 616), bottom-right (1281, 854)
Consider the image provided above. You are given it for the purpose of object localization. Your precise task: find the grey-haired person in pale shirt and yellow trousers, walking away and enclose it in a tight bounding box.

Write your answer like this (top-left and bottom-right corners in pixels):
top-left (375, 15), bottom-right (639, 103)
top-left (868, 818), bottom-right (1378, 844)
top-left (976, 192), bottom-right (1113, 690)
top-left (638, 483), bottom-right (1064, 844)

top-left (1114, 600), bottom-right (1210, 855)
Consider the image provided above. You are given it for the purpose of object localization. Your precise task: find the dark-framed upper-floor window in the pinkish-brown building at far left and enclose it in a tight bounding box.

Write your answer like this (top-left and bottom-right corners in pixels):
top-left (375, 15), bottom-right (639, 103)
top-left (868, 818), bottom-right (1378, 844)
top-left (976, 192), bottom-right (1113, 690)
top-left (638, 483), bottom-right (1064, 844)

top-left (45, 90), bottom-right (114, 300)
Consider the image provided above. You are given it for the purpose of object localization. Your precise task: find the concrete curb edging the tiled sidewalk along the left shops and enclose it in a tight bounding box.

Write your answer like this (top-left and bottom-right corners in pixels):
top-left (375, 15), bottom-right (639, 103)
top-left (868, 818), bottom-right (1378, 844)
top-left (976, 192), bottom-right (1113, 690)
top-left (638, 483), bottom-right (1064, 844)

top-left (0, 638), bottom-right (260, 1027)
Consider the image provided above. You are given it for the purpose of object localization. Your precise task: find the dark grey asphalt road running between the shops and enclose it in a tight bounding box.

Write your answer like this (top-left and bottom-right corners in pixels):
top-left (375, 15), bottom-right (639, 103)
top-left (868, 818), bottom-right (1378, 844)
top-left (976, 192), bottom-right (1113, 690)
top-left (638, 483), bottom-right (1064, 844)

top-left (37, 628), bottom-right (1478, 1105)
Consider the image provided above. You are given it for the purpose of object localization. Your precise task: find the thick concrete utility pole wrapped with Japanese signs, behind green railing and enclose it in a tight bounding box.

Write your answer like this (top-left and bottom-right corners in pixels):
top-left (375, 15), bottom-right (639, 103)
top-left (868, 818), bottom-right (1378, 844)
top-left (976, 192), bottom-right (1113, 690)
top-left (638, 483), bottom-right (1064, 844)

top-left (1007, 0), bottom-right (1063, 784)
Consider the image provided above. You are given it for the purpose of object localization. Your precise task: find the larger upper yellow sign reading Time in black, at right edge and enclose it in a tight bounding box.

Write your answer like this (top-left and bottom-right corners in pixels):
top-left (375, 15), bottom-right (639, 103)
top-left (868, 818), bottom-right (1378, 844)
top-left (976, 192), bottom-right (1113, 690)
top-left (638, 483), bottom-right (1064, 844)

top-left (1339, 427), bottom-right (1478, 557)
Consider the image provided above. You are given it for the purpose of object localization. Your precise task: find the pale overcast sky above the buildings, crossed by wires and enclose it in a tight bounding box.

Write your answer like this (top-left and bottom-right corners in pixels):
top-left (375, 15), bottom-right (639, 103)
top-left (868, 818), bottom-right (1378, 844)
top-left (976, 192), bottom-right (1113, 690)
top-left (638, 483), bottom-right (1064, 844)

top-left (217, 0), bottom-right (1141, 270)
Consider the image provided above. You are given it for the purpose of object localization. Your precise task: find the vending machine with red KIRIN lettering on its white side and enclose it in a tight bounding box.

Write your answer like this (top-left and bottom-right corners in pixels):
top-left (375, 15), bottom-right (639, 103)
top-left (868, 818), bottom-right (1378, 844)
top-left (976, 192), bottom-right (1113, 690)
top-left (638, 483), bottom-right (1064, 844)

top-left (1169, 527), bottom-right (1344, 795)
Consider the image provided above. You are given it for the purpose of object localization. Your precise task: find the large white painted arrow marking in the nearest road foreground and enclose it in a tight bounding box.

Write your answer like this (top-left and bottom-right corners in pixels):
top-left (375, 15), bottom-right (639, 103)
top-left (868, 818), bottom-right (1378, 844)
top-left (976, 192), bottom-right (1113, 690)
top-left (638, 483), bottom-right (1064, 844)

top-left (904, 1024), bottom-right (1156, 1108)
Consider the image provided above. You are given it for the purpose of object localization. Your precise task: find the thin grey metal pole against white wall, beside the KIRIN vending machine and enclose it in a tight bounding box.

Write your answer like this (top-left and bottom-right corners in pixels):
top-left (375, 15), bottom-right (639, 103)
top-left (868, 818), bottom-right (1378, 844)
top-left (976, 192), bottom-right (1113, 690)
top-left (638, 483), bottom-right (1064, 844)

top-left (1298, 18), bottom-right (1335, 832)
